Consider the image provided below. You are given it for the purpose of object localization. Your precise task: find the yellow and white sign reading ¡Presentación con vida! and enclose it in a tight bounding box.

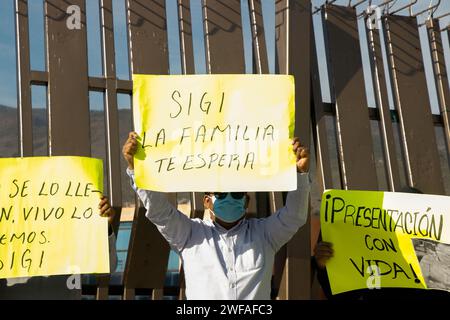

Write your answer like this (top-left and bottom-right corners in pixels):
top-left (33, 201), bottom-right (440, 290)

top-left (321, 190), bottom-right (450, 294)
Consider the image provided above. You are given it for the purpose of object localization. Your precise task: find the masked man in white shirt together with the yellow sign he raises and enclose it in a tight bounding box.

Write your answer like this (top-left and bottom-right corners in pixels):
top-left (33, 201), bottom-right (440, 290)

top-left (123, 75), bottom-right (310, 300)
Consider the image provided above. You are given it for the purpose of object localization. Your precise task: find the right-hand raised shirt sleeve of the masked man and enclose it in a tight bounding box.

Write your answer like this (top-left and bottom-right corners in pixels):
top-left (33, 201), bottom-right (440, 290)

top-left (263, 173), bottom-right (311, 252)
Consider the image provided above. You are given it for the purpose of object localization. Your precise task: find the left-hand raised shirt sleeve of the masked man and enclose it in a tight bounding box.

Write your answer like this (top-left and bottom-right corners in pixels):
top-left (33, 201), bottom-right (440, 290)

top-left (127, 169), bottom-right (193, 252)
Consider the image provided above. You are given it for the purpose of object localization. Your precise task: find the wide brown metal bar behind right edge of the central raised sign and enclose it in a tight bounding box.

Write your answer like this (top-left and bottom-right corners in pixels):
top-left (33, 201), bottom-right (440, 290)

top-left (275, 0), bottom-right (312, 299)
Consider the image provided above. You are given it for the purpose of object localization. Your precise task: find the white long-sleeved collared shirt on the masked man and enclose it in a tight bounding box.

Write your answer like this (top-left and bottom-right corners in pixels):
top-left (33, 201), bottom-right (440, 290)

top-left (127, 170), bottom-right (310, 300)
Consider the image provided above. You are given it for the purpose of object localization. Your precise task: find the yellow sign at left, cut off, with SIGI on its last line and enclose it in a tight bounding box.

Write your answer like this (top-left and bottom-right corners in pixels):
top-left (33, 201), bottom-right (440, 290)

top-left (0, 157), bottom-right (109, 278)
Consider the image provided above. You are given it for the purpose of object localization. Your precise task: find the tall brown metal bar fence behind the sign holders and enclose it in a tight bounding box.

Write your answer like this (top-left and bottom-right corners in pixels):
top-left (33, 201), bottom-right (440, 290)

top-left (0, 0), bottom-right (450, 299)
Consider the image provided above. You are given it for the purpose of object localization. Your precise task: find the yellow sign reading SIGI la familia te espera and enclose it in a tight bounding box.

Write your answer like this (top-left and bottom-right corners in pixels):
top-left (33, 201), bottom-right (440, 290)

top-left (133, 75), bottom-right (297, 192)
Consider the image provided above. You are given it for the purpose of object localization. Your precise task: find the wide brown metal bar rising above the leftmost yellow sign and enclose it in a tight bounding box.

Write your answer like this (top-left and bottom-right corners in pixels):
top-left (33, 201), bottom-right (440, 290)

top-left (45, 0), bottom-right (91, 156)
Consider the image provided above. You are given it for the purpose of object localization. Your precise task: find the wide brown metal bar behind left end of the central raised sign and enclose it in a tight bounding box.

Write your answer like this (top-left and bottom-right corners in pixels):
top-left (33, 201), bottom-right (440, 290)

top-left (124, 0), bottom-right (171, 300)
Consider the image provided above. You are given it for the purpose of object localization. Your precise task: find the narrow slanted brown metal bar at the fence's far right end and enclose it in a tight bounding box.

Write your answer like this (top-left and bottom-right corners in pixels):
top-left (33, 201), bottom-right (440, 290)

top-left (427, 19), bottom-right (450, 161)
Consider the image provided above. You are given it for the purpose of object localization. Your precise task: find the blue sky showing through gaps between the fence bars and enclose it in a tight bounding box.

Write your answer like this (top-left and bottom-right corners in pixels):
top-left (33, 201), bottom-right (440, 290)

top-left (0, 0), bottom-right (450, 112)
